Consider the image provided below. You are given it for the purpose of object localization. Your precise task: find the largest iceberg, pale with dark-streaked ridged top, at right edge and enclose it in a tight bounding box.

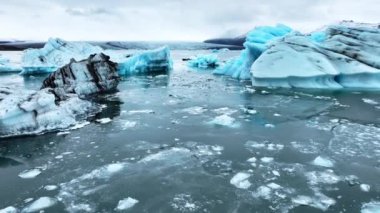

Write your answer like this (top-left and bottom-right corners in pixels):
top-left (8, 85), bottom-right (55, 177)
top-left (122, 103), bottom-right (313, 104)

top-left (251, 22), bottom-right (380, 89)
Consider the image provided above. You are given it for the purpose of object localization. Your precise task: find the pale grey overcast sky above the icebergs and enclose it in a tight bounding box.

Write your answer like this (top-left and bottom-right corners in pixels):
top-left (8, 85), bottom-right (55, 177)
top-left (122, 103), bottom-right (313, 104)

top-left (0, 0), bottom-right (380, 41)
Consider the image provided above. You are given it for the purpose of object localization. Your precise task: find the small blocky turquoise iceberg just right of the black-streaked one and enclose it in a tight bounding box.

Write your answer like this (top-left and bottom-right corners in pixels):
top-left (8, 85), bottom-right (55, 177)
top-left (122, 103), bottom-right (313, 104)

top-left (117, 46), bottom-right (173, 76)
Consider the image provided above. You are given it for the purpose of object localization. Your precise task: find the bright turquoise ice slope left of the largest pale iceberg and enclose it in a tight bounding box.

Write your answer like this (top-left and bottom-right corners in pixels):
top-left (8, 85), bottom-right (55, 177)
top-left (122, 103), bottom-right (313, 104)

top-left (214, 24), bottom-right (292, 79)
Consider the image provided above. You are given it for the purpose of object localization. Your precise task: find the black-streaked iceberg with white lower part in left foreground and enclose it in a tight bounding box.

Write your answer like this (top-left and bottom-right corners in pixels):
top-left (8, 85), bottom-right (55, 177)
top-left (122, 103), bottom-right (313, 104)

top-left (0, 54), bottom-right (119, 137)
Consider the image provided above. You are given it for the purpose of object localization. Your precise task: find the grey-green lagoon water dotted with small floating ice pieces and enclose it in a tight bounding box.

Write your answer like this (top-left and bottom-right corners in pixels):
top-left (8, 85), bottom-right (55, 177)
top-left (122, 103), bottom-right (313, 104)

top-left (0, 50), bottom-right (380, 213)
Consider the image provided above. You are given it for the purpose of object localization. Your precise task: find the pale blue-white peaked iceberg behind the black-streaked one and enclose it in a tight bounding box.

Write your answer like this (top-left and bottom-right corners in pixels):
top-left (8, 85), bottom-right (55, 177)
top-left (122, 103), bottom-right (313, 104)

top-left (21, 38), bottom-right (103, 75)
